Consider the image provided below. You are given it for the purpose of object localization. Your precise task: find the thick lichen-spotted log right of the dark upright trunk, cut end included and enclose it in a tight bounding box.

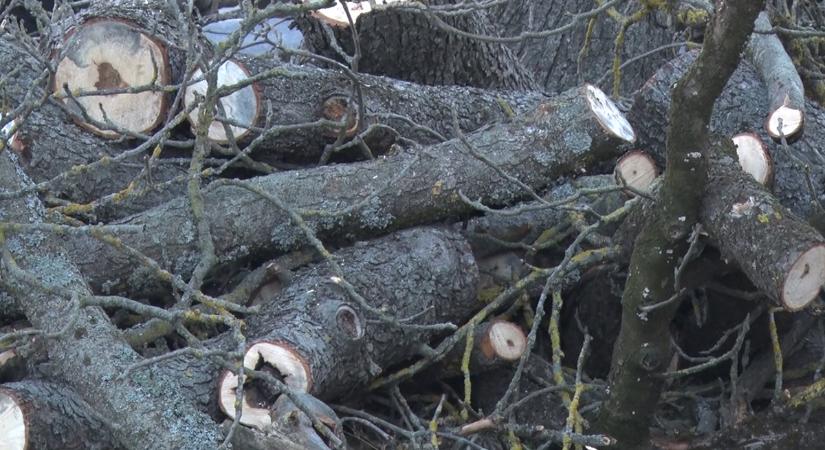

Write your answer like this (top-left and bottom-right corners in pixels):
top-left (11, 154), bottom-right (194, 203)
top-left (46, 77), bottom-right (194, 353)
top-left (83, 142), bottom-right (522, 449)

top-left (702, 140), bottom-right (825, 311)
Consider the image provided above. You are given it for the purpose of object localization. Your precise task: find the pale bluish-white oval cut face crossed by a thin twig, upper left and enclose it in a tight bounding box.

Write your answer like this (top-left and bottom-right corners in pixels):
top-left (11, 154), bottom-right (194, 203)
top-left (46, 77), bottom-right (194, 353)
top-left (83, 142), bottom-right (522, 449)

top-left (184, 60), bottom-right (261, 144)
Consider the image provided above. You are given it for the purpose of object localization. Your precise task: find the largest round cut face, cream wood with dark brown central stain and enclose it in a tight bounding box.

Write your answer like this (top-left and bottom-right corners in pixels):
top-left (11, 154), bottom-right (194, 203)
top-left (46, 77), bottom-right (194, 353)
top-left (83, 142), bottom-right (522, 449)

top-left (52, 19), bottom-right (171, 138)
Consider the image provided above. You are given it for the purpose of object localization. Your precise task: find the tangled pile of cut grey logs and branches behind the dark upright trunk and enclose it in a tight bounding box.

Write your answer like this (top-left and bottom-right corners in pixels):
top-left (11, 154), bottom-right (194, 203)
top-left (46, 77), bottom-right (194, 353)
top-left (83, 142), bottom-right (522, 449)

top-left (0, 0), bottom-right (825, 450)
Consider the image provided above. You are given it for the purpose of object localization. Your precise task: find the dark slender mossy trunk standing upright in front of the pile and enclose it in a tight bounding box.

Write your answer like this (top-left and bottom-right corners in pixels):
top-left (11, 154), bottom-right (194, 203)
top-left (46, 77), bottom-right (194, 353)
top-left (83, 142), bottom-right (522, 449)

top-left (598, 0), bottom-right (764, 449)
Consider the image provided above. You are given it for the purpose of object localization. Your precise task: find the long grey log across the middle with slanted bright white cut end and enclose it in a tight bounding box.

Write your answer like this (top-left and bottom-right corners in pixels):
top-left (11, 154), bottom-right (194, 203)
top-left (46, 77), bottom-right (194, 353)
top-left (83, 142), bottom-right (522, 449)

top-left (65, 86), bottom-right (635, 298)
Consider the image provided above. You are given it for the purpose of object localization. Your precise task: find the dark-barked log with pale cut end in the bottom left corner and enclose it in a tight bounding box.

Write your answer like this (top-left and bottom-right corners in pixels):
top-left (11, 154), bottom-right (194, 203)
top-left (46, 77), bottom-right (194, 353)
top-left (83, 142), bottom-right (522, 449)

top-left (0, 380), bottom-right (121, 450)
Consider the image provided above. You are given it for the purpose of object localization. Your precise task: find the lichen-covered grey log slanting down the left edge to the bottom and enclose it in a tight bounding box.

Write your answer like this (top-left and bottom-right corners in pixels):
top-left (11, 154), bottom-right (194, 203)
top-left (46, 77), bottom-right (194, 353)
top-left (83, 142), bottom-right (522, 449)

top-left (0, 152), bottom-right (225, 449)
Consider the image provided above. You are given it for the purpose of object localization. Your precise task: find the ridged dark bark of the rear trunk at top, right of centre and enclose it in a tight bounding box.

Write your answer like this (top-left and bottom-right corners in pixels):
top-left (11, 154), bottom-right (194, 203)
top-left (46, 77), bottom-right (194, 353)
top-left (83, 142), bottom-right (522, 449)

top-left (490, 0), bottom-right (673, 93)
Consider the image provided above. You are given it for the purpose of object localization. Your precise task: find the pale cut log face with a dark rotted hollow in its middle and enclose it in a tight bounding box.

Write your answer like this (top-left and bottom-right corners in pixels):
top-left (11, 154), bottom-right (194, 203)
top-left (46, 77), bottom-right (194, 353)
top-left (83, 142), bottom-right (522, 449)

top-left (218, 342), bottom-right (312, 430)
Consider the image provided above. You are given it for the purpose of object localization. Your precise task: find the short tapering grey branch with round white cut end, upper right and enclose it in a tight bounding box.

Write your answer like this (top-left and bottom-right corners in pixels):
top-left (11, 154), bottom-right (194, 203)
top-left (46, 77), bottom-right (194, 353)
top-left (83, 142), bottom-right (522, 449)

top-left (748, 11), bottom-right (805, 142)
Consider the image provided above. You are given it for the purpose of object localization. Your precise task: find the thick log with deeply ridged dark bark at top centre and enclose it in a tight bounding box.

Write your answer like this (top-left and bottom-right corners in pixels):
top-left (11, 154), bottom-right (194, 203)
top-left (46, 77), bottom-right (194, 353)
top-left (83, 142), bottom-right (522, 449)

top-left (299, 0), bottom-right (535, 90)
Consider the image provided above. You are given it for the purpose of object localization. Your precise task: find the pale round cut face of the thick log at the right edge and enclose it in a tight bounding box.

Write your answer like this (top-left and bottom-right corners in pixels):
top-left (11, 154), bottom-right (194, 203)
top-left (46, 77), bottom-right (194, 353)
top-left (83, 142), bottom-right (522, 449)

top-left (781, 244), bottom-right (825, 311)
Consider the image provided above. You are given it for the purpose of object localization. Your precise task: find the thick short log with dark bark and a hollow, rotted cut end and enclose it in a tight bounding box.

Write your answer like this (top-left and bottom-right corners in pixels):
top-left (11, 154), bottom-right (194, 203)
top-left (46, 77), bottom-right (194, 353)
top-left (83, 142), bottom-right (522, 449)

top-left (219, 228), bottom-right (480, 428)
